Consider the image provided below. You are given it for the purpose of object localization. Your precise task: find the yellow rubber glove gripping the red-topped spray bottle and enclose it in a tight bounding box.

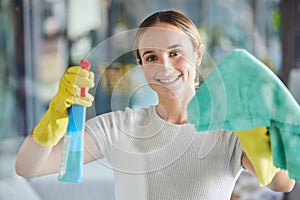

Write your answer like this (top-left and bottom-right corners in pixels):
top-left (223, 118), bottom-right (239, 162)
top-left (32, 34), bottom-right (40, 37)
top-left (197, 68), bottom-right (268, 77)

top-left (33, 66), bottom-right (94, 146)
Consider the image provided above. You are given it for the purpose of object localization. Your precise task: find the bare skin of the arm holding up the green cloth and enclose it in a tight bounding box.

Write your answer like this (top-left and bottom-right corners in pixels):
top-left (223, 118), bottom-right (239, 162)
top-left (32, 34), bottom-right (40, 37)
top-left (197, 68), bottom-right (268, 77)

top-left (242, 154), bottom-right (295, 192)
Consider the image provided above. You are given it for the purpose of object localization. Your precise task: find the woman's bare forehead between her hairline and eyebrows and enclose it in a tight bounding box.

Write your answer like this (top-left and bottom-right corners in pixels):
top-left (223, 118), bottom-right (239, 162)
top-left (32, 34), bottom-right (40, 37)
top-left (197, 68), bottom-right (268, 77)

top-left (139, 23), bottom-right (192, 49)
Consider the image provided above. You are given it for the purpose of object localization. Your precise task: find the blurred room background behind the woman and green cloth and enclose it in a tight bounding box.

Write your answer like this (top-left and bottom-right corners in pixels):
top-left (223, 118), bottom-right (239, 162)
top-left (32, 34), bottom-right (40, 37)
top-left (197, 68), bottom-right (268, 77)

top-left (0, 0), bottom-right (300, 200)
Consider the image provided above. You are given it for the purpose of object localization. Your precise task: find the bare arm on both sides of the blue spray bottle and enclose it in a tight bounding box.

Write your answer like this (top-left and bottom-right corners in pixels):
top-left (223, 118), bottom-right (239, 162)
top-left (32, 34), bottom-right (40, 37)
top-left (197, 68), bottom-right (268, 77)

top-left (16, 132), bottom-right (101, 178)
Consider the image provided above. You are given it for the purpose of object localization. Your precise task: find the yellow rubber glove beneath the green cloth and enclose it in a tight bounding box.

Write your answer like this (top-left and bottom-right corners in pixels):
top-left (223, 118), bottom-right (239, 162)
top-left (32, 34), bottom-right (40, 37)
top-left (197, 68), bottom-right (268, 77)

top-left (234, 127), bottom-right (280, 186)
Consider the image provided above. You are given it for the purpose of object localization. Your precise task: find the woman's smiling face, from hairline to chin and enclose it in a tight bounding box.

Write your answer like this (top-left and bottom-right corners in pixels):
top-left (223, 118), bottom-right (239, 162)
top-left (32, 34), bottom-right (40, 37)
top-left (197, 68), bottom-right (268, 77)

top-left (139, 22), bottom-right (202, 98)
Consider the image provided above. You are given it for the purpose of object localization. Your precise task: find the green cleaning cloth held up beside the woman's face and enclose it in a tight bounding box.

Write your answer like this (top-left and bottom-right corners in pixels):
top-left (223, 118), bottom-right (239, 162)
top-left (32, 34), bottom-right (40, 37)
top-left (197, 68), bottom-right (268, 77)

top-left (188, 50), bottom-right (300, 181)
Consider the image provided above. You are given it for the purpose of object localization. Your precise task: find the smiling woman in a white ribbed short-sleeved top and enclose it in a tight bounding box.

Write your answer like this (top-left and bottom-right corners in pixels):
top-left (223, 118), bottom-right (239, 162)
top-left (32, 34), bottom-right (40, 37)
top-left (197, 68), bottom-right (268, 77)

top-left (16, 10), bottom-right (294, 200)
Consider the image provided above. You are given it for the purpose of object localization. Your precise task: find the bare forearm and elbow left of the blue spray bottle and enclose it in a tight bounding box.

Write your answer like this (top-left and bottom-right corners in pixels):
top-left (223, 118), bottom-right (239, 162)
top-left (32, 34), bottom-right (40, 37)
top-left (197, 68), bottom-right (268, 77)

top-left (15, 133), bottom-right (62, 178)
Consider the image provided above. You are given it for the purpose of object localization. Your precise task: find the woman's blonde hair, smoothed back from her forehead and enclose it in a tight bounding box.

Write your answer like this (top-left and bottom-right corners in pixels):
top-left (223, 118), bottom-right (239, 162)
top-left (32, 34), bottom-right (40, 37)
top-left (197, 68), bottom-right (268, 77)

top-left (133, 10), bottom-right (202, 64)
